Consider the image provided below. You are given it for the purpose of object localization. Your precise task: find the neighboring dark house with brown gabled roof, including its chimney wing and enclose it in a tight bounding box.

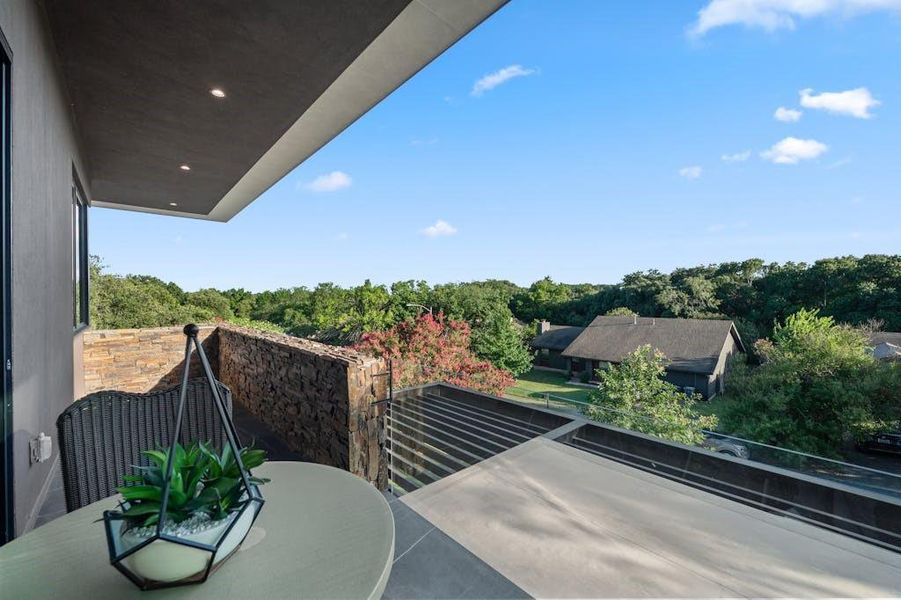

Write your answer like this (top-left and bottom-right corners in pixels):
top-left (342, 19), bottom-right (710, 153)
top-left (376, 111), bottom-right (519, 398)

top-left (533, 316), bottom-right (745, 398)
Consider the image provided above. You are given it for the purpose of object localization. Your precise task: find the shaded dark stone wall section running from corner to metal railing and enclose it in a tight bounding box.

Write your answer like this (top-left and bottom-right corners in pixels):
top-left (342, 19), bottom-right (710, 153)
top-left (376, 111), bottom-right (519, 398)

top-left (219, 325), bottom-right (388, 489)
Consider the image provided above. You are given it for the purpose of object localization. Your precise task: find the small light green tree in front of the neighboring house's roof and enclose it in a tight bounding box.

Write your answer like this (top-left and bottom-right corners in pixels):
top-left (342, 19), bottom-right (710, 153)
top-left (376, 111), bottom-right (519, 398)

top-left (585, 346), bottom-right (716, 444)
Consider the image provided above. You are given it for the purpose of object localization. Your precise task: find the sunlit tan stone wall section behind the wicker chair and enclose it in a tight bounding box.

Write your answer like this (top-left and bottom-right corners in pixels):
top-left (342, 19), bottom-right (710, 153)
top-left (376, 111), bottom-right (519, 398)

top-left (82, 325), bottom-right (219, 394)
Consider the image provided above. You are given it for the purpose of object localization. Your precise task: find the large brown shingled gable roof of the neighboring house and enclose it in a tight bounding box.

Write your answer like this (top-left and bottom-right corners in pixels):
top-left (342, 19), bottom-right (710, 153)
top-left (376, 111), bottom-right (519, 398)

top-left (563, 316), bottom-right (745, 374)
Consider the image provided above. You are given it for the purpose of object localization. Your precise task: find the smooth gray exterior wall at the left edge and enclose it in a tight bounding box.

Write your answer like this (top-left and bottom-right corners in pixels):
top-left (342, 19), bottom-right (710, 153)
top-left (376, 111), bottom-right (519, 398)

top-left (0, 0), bottom-right (90, 535)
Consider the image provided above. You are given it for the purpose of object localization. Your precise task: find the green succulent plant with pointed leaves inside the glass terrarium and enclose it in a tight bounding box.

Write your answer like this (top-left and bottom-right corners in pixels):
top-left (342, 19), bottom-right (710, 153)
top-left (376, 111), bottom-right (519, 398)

top-left (116, 442), bottom-right (269, 528)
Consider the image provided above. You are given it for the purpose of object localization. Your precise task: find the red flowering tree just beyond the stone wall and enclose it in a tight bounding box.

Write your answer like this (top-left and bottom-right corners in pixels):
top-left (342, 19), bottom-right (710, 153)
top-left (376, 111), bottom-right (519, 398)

top-left (354, 313), bottom-right (514, 396)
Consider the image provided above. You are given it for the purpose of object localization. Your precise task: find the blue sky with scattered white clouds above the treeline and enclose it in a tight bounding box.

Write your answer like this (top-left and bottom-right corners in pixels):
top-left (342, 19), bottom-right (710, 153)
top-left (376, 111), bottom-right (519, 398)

top-left (90, 0), bottom-right (901, 291)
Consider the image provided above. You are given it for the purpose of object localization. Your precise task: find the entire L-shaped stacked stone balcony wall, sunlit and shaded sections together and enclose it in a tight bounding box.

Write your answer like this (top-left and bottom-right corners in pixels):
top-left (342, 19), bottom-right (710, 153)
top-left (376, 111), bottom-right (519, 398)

top-left (83, 324), bottom-right (388, 489)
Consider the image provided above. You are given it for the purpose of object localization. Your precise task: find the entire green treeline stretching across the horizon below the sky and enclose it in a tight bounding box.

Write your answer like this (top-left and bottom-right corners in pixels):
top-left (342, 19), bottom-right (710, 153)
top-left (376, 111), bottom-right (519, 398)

top-left (91, 255), bottom-right (901, 366)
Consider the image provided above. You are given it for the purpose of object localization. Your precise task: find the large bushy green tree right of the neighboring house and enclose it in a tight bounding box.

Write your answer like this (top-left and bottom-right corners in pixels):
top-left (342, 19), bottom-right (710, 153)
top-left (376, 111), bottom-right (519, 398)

top-left (720, 309), bottom-right (901, 456)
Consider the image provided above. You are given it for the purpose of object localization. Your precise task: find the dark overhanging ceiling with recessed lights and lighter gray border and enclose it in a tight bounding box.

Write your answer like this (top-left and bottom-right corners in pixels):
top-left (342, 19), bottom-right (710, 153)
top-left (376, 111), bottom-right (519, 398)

top-left (44, 0), bottom-right (506, 221)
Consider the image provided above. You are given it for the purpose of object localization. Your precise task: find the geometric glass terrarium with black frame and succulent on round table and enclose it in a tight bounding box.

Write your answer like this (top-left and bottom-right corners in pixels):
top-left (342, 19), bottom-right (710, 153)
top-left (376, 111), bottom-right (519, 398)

top-left (103, 324), bottom-right (265, 590)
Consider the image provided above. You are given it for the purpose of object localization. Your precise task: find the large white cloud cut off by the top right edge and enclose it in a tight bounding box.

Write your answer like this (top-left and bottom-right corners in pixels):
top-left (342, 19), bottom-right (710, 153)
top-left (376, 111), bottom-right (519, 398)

top-left (688, 0), bottom-right (901, 37)
